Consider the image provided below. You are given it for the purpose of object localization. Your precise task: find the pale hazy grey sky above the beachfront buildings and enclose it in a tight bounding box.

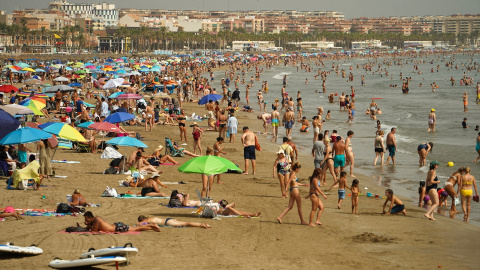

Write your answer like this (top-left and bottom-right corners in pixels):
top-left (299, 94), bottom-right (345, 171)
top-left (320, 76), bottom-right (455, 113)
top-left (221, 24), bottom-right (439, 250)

top-left (0, 0), bottom-right (480, 18)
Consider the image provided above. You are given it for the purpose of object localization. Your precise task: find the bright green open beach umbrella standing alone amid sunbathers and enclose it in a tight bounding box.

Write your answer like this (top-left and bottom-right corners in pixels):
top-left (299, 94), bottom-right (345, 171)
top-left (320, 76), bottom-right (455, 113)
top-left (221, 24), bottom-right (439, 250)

top-left (178, 156), bottom-right (242, 175)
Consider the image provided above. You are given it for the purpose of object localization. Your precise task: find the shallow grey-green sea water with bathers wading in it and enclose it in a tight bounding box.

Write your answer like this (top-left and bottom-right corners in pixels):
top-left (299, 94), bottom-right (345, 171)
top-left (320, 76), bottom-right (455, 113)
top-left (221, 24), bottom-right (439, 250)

top-left (215, 54), bottom-right (480, 225)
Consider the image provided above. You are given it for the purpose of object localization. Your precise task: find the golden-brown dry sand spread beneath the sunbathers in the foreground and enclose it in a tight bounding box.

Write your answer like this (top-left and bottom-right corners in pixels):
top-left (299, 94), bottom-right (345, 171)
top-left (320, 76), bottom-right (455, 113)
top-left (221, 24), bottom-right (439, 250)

top-left (0, 68), bottom-right (480, 269)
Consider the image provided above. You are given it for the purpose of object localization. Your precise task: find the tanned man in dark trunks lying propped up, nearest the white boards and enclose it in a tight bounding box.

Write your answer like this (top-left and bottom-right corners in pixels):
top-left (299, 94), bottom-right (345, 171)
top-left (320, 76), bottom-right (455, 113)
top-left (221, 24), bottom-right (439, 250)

top-left (83, 211), bottom-right (160, 233)
